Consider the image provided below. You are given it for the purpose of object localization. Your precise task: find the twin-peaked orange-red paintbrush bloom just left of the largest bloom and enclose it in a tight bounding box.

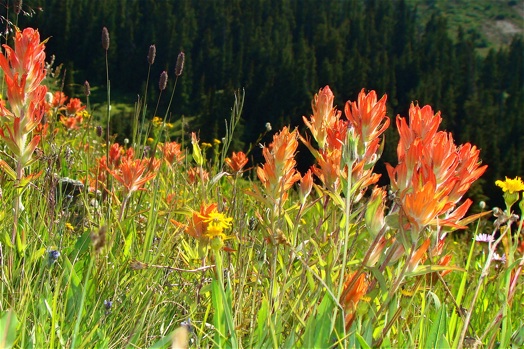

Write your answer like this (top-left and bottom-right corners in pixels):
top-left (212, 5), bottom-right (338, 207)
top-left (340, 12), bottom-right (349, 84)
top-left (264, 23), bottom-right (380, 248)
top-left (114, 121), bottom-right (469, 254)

top-left (301, 86), bottom-right (389, 193)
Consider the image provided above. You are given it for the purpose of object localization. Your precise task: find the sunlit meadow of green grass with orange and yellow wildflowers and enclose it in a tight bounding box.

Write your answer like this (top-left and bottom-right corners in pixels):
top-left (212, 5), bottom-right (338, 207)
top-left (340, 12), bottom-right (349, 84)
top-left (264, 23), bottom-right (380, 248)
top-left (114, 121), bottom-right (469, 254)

top-left (0, 28), bottom-right (524, 348)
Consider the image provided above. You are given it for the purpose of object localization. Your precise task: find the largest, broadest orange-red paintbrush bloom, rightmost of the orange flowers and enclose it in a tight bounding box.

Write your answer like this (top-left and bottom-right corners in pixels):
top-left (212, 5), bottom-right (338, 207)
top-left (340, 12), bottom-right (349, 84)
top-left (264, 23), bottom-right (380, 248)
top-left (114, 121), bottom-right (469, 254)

top-left (386, 104), bottom-right (487, 236)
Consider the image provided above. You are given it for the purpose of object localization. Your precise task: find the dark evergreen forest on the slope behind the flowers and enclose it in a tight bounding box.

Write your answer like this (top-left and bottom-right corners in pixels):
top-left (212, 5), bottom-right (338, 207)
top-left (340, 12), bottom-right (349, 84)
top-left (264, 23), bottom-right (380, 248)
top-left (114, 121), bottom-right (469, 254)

top-left (12, 0), bottom-right (524, 204)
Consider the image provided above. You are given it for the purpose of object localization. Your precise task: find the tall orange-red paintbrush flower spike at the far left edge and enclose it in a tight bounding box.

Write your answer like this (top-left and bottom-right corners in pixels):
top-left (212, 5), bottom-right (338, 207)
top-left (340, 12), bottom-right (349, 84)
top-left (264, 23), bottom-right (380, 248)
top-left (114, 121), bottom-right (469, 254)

top-left (0, 28), bottom-right (47, 180)
